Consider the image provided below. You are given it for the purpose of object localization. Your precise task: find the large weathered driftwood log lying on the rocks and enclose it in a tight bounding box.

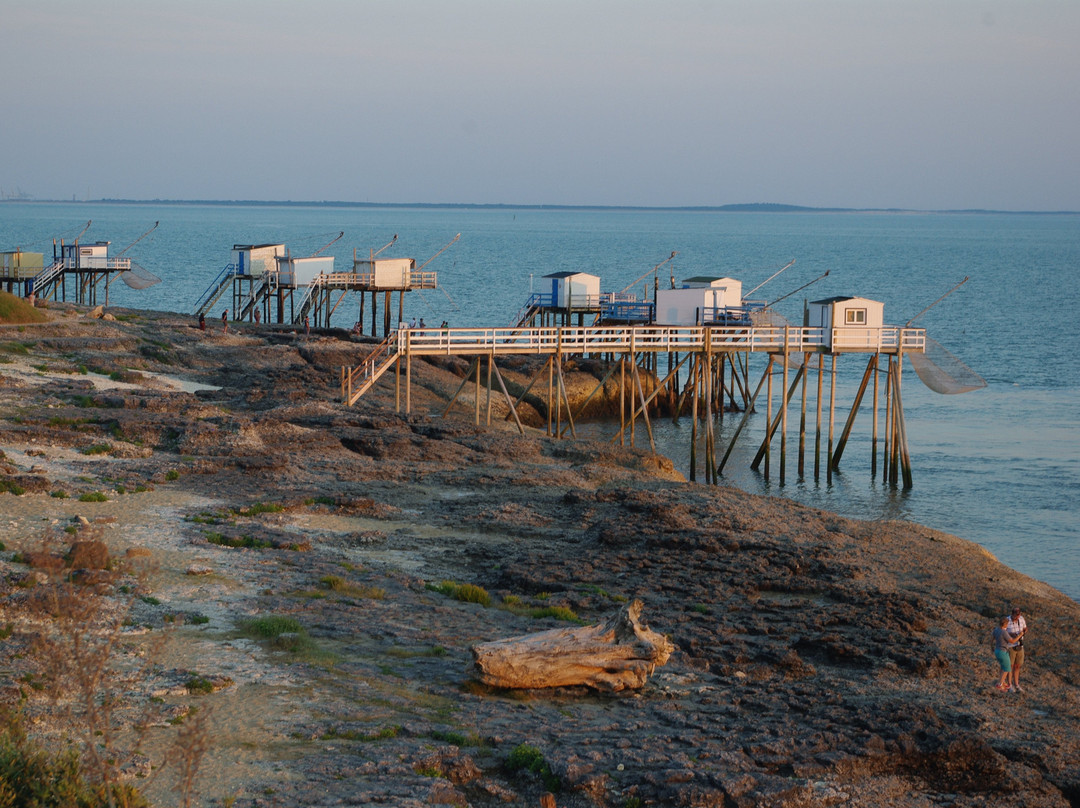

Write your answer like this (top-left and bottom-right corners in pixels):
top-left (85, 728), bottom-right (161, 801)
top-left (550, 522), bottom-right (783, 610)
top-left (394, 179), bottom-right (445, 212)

top-left (472, 601), bottom-right (674, 690)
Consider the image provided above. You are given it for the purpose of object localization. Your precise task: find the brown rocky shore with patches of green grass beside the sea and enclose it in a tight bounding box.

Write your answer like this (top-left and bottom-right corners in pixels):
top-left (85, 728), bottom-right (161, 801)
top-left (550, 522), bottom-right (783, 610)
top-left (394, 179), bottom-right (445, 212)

top-left (0, 305), bottom-right (1080, 808)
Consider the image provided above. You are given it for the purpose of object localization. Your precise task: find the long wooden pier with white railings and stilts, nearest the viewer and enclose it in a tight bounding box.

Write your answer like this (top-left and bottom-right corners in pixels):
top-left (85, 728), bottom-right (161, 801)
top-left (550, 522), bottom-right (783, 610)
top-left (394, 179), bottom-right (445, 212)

top-left (340, 325), bottom-right (926, 488)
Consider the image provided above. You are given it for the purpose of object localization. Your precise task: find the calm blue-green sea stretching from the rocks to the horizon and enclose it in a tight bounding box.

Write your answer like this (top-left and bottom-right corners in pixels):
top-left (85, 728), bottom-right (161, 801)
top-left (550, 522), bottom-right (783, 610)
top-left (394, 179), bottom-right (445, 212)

top-left (0, 201), bottom-right (1080, 600)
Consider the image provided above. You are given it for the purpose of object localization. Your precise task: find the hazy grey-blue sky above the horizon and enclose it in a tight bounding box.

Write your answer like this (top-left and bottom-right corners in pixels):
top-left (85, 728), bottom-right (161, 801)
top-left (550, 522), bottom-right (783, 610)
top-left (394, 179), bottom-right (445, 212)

top-left (0, 0), bottom-right (1080, 211)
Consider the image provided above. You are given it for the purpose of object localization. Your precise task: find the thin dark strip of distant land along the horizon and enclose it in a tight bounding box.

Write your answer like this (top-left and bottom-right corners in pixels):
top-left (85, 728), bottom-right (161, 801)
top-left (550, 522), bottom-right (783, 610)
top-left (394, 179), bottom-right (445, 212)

top-left (0, 199), bottom-right (1080, 216)
